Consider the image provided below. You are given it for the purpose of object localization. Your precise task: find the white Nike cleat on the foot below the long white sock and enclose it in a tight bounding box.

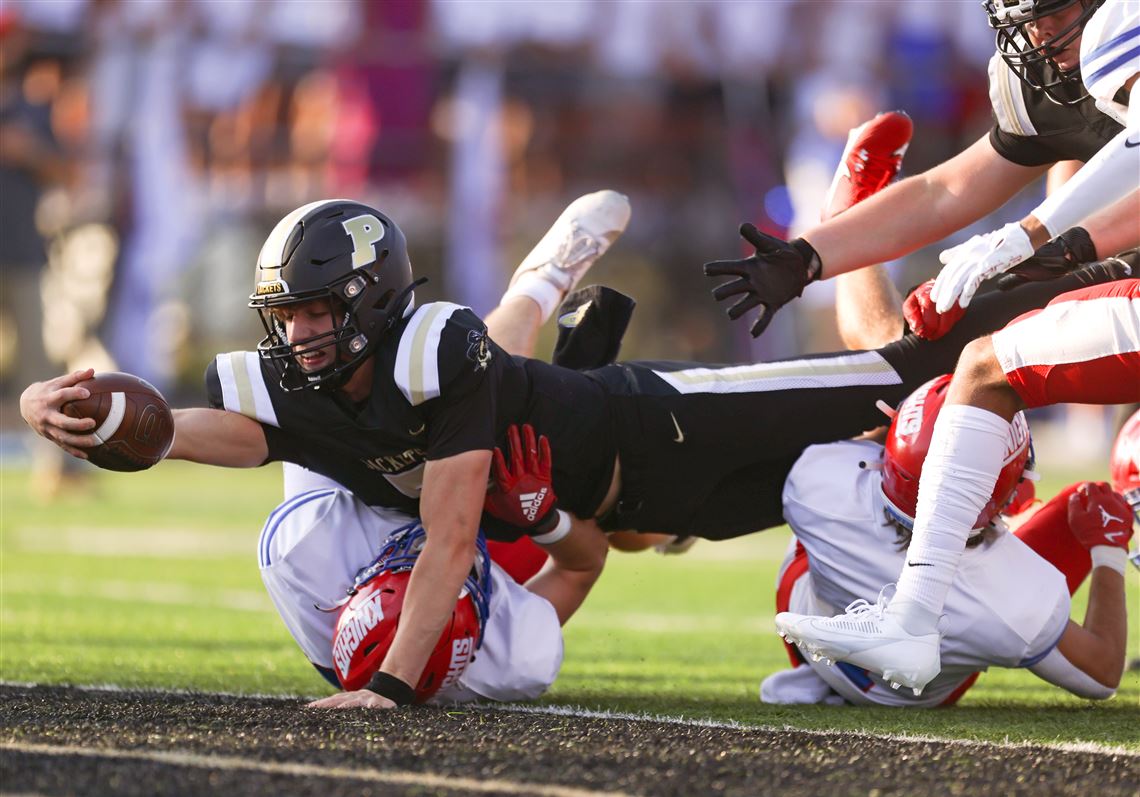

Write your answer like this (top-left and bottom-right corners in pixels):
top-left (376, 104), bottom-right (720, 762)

top-left (776, 593), bottom-right (942, 696)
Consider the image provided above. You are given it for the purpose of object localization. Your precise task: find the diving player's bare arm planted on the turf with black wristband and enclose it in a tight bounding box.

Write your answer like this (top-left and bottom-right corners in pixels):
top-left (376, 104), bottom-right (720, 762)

top-left (310, 450), bottom-right (491, 708)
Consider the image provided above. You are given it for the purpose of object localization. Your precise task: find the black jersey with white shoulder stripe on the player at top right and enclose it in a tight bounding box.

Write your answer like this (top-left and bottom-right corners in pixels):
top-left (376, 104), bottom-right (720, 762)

top-left (990, 54), bottom-right (1123, 166)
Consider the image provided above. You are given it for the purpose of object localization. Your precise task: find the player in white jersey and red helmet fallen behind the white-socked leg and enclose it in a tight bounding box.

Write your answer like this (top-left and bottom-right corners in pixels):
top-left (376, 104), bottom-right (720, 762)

top-left (760, 376), bottom-right (1140, 707)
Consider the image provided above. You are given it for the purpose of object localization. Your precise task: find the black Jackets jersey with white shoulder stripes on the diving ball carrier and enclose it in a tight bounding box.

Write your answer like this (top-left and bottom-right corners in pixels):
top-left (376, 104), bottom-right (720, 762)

top-left (206, 302), bottom-right (616, 526)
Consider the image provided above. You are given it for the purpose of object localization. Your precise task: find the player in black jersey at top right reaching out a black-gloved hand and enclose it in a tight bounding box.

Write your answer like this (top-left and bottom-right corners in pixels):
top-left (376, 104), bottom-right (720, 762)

top-left (706, 0), bottom-right (1127, 335)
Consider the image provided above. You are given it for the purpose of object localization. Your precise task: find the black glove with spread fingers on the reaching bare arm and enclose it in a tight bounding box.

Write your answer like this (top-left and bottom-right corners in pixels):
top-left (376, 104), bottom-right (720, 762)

top-left (705, 223), bottom-right (823, 337)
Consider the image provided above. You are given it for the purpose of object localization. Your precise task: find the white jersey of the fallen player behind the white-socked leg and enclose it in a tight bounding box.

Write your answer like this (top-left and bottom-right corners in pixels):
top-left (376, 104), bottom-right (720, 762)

top-left (770, 441), bottom-right (1069, 706)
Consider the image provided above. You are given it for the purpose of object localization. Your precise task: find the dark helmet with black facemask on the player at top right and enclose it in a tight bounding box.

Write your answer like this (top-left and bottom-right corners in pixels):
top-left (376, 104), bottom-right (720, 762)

top-left (983, 0), bottom-right (1105, 105)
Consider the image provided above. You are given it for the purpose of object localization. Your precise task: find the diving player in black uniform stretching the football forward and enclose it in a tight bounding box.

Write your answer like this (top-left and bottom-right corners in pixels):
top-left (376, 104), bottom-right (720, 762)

top-left (21, 127), bottom-right (1135, 707)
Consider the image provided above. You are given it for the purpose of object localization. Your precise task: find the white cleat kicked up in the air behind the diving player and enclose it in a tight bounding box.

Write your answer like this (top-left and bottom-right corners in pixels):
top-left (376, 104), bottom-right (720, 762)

top-left (511, 190), bottom-right (629, 296)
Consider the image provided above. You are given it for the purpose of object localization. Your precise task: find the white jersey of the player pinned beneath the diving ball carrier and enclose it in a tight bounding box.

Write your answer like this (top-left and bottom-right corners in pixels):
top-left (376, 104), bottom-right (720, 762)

top-left (258, 485), bottom-right (562, 702)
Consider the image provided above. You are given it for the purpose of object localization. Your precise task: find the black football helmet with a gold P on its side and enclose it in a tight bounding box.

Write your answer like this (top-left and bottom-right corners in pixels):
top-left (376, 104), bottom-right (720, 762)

top-left (250, 200), bottom-right (416, 390)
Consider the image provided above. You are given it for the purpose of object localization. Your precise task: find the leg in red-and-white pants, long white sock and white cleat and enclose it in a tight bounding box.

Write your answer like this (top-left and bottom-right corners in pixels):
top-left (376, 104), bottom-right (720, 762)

top-left (776, 279), bottom-right (1140, 693)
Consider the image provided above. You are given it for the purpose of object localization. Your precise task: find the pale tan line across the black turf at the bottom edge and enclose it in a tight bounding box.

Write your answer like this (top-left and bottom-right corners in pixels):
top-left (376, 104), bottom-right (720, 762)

top-left (0, 742), bottom-right (626, 797)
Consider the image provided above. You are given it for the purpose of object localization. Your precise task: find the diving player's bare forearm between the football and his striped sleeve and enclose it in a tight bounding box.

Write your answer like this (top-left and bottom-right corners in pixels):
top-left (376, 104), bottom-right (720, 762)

top-left (166, 407), bottom-right (269, 467)
